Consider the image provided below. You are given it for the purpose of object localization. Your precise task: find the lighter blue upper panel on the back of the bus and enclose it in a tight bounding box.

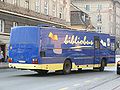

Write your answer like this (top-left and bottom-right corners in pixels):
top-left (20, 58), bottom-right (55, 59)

top-left (10, 27), bottom-right (38, 44)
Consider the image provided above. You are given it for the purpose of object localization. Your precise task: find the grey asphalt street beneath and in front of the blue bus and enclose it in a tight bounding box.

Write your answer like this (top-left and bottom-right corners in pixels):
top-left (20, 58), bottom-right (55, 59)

top-left (0, 67), bottom-right (120, 90)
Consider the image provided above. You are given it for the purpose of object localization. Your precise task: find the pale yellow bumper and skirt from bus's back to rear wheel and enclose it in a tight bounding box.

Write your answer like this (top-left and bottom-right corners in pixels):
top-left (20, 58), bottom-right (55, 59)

top-left (9, 63), bottom-right (63, 70)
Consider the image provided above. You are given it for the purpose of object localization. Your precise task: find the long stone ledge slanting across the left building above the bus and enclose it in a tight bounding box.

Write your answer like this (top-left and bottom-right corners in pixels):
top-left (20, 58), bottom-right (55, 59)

top-left (0, 1), bottom-right (67, 26)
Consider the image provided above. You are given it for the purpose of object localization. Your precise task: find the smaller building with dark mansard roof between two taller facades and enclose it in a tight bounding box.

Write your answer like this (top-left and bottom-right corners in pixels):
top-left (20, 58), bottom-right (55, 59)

top-left (70, 3), bottom-right (94, 31)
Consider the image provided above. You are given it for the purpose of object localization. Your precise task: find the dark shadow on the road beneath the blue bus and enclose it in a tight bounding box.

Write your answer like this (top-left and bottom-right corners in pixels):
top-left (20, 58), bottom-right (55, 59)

top-left (12, 70), bottom-right (115, 77)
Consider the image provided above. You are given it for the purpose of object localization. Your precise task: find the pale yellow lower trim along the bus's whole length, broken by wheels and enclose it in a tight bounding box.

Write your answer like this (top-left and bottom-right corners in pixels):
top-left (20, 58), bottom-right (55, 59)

top-left (9, 63), bottom-right (115, 70)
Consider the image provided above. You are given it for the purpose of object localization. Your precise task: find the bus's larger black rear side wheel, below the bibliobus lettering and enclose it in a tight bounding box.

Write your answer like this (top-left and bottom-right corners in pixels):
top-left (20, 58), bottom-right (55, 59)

top-left (63, 60), bottom-right (72, 74)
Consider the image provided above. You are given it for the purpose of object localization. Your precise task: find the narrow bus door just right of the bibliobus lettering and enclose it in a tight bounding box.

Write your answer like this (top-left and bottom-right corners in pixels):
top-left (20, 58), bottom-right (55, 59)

top-left (94, 36), bottom-right (100, 64)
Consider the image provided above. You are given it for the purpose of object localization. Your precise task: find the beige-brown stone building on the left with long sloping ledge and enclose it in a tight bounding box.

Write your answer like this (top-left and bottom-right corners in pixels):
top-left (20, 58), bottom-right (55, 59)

top-left (0, 0), bottom-right (70, 60)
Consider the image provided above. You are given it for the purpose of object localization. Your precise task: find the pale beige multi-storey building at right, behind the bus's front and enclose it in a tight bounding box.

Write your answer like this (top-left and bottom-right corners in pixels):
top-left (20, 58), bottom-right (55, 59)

top-left (71, 0), bottom-right (120, 44)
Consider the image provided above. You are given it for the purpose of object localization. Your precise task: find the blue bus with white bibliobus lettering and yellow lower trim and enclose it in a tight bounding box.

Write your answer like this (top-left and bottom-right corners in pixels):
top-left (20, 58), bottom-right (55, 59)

top-left (8, 26), bottom-right (115, 74)
